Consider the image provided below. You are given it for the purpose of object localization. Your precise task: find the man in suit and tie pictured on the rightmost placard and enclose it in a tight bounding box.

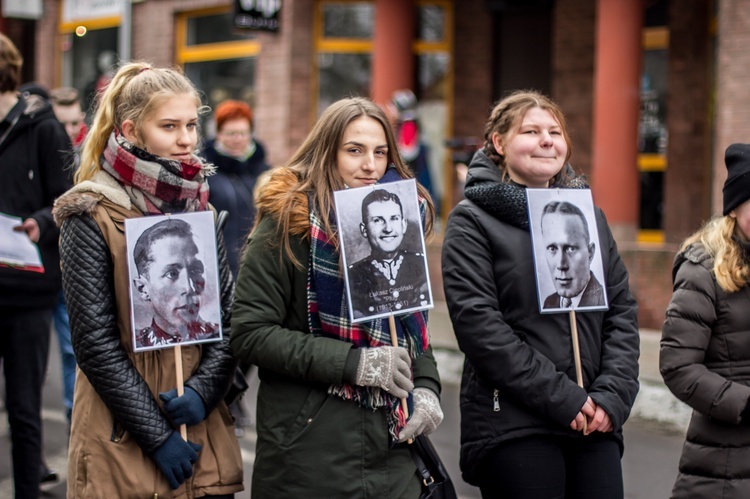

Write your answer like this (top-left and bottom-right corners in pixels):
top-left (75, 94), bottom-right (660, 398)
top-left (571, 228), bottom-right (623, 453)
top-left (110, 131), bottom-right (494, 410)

top-left (541, 201), bottom-right (606, 309)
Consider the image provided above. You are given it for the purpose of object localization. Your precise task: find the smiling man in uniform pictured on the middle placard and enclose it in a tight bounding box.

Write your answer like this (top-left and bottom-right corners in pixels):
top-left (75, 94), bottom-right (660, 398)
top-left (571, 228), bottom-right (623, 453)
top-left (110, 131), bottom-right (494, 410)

top-left (338, 183), bottom-right (432, 320)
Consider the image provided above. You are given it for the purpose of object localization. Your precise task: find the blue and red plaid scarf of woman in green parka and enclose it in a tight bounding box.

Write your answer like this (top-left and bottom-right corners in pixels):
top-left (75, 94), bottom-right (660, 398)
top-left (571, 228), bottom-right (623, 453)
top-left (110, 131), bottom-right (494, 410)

top-left (307, 168), bottom-right (429, 441)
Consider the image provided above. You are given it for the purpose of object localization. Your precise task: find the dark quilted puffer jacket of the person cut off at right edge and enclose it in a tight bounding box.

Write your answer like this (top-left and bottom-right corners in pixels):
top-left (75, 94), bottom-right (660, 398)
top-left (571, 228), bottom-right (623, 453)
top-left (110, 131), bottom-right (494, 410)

top-left (659, 244), bottom-right (750, 499)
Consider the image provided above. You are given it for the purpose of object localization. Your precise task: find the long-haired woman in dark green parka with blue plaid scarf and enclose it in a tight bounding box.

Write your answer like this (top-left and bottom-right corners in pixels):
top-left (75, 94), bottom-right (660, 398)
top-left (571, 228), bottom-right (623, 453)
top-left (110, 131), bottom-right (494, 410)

top-left (231, 98), bottom-right (443, 499)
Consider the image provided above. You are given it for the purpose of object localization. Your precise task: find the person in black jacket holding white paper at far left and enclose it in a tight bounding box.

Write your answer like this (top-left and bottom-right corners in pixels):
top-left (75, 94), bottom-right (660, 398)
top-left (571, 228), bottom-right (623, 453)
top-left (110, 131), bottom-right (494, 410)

top-left (0, 34), bottom-right (72, 499)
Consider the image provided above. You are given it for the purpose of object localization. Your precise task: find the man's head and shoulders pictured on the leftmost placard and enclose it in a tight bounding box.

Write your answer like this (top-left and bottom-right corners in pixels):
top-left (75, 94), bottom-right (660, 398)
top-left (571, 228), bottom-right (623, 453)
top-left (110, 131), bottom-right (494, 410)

top-left (132, 217), bottom-right (221, 349)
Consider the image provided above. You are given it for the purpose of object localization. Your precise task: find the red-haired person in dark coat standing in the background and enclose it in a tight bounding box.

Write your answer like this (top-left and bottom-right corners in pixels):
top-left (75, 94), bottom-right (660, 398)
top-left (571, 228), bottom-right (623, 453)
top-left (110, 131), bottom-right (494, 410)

top-left (203, 100), bottom-right (270, 278)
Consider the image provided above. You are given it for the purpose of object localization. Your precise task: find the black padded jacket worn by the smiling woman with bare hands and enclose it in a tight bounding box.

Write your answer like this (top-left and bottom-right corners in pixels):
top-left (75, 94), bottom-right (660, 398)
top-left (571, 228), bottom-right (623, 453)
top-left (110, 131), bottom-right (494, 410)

top-left (443, 151), bottom-right (639, 483)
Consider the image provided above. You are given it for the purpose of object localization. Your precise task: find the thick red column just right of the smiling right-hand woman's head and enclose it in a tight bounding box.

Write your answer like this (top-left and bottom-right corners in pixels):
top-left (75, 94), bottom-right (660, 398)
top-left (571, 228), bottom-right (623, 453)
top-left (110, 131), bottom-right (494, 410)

top-left (591, 0), bottom-right (643, 230)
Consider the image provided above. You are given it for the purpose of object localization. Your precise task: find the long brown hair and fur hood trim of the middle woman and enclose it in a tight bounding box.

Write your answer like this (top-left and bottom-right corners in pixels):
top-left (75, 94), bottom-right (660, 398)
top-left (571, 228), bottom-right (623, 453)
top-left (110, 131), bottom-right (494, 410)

top-left (256, 97), bottom-right (435, 266)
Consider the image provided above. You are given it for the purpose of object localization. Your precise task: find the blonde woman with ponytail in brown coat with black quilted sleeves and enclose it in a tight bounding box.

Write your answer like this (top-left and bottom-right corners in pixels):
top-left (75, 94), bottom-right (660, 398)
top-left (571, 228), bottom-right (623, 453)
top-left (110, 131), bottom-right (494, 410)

top-left (55, 62), bottom-right (243, 499)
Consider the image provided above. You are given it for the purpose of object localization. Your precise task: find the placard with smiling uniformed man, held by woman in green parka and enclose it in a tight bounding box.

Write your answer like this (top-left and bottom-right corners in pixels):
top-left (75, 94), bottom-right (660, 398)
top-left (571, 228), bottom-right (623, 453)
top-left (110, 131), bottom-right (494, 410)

top-left (334, 179), bottom-right (433, 323)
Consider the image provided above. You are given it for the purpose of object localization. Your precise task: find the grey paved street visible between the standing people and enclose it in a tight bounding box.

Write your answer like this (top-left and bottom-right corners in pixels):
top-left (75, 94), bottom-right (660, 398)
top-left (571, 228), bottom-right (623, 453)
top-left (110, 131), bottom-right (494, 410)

top-left (0, 335), bottom-right (683, 499)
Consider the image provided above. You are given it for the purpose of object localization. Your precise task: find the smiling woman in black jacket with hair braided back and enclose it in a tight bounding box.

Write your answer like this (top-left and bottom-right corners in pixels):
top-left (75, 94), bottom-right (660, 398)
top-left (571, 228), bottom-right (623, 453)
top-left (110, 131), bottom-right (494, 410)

top-left (443, 92), bottom-right (639, 499)
